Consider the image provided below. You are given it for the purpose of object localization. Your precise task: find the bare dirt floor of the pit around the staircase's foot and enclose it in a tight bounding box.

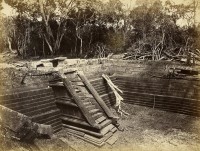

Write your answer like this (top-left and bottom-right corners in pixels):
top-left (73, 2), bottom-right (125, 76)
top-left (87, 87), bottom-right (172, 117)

top-left (58, 104), bottom-right (200, 151)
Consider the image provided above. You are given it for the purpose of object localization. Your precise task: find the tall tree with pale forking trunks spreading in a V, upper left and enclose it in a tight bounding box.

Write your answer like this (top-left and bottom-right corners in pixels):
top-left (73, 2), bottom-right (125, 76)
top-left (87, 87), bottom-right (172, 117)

top-left (4, 0), bottom-right (74, 55)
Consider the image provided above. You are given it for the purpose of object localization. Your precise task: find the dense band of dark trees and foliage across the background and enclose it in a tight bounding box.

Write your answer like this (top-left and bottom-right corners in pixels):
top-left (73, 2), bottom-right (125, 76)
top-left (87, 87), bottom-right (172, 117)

top-left (0, 0), bottom-right (199, 60)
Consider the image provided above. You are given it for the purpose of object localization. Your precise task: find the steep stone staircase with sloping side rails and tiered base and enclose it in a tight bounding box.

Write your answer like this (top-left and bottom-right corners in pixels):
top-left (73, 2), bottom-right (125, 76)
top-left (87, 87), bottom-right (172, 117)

top-left (50, 70), bottom-right (117, 146)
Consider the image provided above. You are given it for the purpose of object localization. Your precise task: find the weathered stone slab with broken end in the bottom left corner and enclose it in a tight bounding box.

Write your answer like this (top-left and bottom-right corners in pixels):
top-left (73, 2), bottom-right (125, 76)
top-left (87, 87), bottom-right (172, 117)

top-left (0, 105), bottom-right (53, 141)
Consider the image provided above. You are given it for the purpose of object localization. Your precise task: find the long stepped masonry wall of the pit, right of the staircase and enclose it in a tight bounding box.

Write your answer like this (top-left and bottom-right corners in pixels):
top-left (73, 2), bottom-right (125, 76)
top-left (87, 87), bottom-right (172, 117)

top-left (77, 60), bottom-right (200, 116)
